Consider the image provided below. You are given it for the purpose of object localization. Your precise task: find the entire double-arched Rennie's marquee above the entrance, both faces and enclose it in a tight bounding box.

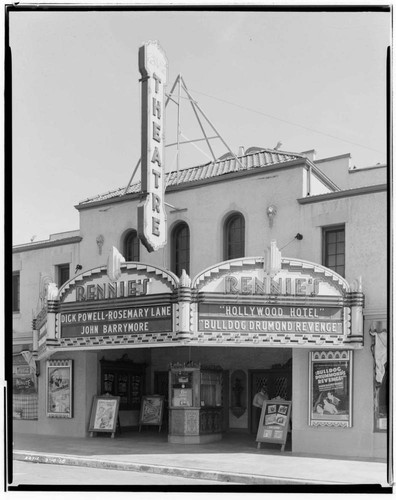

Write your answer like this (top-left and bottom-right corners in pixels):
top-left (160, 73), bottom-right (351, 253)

top-left (35, 244), bottom-right (364, 353)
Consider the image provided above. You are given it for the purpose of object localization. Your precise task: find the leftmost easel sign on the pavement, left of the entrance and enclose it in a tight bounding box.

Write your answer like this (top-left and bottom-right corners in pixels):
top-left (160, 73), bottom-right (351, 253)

top-left (88, 396), bottom-right (120, 438)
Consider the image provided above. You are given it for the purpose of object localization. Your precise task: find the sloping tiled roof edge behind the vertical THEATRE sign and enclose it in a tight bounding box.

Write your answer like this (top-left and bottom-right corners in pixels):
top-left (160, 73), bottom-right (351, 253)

top-left (79, 149), bottom-right (304, 205)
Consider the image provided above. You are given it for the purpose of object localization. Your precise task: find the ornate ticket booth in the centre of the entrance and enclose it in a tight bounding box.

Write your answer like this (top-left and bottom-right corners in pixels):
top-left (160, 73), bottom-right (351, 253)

top-left (168, 362), bottom-right (223, 444)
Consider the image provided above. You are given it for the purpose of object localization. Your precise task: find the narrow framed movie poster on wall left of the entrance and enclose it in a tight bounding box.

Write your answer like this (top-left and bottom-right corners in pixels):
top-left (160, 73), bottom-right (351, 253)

top-left (46, 359), bottom-right (73, 418)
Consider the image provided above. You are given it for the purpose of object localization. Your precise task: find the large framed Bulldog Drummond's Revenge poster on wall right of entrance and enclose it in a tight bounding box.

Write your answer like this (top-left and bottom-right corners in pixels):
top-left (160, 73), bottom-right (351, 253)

top-left (308, 350), bottom-right (352, 427)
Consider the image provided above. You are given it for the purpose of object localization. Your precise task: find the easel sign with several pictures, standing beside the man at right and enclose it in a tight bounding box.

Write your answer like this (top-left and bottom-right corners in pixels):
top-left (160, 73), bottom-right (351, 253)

top-left (256, 399), bottom-right (291, 451)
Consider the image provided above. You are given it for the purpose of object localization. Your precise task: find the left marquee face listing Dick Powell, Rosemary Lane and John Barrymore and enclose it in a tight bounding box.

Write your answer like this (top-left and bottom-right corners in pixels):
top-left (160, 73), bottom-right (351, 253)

top-left (58, 262), bottom-right (177, 345)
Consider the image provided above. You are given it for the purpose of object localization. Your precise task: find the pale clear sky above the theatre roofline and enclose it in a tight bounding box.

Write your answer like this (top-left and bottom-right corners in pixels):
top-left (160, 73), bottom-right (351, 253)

top-left (9, 4), bottom-right (390, 245)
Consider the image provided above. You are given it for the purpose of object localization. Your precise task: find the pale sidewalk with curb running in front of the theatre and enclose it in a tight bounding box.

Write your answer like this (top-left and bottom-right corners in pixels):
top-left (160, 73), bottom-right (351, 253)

top-left (13, 429), bottom-right (389, 487)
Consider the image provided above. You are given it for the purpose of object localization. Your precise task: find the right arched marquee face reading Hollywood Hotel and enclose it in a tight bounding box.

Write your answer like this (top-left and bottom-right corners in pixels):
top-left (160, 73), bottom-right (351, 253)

top-left (193, 242), bottom-right (363, 347)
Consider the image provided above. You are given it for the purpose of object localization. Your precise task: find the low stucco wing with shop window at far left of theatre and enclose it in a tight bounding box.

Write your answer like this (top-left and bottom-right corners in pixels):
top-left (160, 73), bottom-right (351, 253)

top-left (12, 231), bottom-right (81, 420)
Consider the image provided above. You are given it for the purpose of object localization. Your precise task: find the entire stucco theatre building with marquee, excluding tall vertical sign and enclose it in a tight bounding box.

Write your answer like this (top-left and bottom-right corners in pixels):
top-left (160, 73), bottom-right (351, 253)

top-left (13, 147), bottom-right (388, 459)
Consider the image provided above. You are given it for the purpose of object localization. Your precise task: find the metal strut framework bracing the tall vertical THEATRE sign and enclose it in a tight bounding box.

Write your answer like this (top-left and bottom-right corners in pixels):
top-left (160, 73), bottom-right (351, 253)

top-left (124, 74), bottom-right (244, 195)
